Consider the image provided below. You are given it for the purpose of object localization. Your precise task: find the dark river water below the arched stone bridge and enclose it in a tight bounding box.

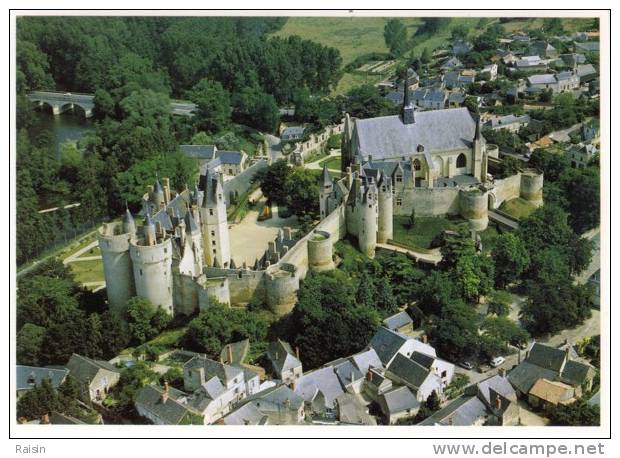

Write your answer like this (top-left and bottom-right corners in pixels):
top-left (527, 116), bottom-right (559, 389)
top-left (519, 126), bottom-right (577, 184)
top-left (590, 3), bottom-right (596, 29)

top-left (30, 111), bottom-right (93, 159)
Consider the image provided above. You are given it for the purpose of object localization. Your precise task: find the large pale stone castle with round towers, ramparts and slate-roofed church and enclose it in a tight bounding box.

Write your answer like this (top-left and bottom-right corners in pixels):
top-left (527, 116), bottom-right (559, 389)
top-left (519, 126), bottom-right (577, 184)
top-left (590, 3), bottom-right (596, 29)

top-left (98, 81), bottom-right (543, 315)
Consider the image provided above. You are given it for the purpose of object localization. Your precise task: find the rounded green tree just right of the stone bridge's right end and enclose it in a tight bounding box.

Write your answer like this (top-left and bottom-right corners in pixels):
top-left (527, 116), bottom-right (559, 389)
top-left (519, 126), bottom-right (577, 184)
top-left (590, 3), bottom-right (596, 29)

top-left (188, 78), bottom-right (232, 132)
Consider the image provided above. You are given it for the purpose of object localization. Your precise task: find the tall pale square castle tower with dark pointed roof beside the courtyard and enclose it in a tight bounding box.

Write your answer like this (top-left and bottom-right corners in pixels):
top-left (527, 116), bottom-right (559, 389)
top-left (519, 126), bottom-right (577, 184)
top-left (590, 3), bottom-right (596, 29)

top-left (200, 171), bottom-right (230, 268)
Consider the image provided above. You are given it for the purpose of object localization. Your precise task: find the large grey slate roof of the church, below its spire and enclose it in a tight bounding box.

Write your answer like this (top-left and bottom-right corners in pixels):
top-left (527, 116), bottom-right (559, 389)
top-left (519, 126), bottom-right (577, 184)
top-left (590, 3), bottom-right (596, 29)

top-left (355, 108), bottom-right (476, 159)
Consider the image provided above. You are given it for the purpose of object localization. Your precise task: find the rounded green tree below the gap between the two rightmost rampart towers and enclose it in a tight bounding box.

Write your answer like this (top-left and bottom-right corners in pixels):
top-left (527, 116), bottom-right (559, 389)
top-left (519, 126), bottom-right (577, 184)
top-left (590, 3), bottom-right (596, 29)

top-left (492, 232), bottom-right (530, 288)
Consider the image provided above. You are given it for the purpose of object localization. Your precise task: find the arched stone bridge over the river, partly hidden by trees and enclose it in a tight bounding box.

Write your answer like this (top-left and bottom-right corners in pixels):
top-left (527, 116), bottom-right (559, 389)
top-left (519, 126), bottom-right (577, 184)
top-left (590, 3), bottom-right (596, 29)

top-left (27, 91), bottom-right (196, 118)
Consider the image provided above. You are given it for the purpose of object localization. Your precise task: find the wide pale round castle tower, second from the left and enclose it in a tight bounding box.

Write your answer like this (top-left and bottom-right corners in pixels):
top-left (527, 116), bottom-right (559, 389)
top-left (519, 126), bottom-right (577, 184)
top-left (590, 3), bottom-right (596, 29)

top-left (129, 213), bottom-right (173, 315)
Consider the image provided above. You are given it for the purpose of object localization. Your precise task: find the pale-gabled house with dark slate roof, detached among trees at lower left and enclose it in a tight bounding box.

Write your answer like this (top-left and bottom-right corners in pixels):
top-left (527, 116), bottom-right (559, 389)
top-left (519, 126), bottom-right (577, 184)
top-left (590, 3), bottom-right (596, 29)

top-left (67, 353), bottom-right (120, 402)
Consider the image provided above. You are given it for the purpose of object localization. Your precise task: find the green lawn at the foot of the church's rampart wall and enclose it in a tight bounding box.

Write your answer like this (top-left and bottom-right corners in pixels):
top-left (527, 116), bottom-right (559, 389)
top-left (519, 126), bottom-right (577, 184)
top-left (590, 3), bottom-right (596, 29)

top-left (394, 216), bottom-right (467, 250)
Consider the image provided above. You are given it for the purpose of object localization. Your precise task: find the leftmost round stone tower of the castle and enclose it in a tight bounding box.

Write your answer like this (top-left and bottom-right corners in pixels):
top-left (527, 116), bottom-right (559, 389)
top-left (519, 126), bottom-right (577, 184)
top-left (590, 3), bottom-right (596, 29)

top-left (97, 209), bottom-right (136, 315)
